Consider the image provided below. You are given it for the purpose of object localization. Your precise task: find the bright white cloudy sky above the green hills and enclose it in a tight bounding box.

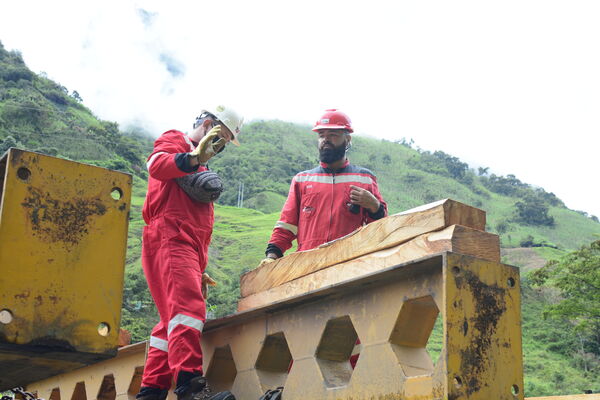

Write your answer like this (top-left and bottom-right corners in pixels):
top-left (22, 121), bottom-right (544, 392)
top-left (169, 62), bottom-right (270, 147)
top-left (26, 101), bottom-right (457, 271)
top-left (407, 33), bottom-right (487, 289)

top-left (0, 0), bottom-right (600, 216)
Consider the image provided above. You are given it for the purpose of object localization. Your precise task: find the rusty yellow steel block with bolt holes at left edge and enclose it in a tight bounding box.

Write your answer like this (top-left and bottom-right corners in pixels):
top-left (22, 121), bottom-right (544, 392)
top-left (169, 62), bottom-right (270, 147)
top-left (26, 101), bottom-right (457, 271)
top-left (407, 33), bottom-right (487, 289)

top-left (0, 149), bottom-right (132, 390)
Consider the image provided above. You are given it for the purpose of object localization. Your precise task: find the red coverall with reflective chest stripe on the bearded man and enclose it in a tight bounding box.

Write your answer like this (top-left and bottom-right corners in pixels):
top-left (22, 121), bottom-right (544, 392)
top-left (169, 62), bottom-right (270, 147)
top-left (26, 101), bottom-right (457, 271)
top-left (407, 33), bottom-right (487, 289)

top-left (267, 160), bottom-right (387, 368)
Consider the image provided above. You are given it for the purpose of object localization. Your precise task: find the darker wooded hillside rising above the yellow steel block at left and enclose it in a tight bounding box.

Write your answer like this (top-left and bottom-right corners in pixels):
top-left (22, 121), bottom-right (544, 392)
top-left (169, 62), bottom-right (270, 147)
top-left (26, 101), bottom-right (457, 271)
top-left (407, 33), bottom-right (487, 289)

top-left (0, 43), bottom-right (153, 179)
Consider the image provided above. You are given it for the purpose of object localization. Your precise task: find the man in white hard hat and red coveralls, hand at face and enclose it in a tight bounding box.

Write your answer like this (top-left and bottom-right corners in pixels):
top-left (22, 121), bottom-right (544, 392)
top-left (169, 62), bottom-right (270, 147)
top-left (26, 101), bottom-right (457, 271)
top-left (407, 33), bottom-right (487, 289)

top-left (136, 106), bottom-right (243, 400)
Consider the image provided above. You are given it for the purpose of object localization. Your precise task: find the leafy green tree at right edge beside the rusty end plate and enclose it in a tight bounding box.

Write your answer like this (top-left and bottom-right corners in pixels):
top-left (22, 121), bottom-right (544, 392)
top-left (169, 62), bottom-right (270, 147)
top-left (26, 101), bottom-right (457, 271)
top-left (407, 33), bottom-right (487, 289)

top-left (530, 240), bottom-right (600, 370)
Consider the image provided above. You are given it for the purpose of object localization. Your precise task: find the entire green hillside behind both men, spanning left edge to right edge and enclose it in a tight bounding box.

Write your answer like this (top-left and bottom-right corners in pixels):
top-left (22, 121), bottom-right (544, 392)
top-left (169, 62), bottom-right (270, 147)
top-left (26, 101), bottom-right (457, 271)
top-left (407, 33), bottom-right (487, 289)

top-left (0, 44), bottom-right (600, 396)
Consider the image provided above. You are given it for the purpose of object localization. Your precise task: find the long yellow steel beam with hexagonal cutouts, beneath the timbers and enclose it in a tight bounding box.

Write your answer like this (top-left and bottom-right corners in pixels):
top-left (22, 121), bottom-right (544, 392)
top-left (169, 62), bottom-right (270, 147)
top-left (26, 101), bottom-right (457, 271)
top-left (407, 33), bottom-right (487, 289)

top-left (28, 252), bottom-right (524, 400)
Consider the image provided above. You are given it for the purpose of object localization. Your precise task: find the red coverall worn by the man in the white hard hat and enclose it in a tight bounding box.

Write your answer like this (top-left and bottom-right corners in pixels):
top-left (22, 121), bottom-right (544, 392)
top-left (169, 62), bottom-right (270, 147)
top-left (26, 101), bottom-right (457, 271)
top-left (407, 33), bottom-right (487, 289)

top-left (142, 130), bottom-right (214, 389)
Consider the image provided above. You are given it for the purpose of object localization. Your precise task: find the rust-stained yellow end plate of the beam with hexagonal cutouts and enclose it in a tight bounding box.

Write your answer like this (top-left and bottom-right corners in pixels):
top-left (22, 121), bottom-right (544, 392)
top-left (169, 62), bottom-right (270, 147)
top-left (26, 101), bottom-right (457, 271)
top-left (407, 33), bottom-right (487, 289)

top-left (444, 253), bottom-right (523, 400)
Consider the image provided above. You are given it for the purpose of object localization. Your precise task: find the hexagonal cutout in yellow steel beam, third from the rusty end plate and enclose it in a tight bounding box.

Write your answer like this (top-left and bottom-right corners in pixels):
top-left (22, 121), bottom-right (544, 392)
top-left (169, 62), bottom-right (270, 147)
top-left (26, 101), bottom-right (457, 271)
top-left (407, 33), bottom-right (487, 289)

top-left (255, 332), bottom-right (292, 391)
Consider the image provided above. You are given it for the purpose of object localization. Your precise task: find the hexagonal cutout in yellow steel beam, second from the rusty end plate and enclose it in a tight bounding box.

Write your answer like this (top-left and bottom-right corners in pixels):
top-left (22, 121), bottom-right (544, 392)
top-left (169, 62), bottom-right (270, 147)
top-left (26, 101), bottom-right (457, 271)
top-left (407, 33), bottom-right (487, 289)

top-left (315, 315), bottom-right (358, 388)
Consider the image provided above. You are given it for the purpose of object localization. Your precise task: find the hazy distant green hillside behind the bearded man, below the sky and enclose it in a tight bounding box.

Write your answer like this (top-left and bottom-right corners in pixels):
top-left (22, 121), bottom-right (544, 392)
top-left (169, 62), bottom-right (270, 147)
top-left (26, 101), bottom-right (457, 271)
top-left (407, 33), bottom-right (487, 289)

top-left (211, 125), bottom-right (600, 250)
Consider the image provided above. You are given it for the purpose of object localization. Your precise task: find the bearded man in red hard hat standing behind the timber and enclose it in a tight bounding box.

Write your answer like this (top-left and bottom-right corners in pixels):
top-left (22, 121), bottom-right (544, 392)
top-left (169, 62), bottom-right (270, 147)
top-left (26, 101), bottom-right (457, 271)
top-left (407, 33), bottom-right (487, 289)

top-left (263, 109), bottom-right (387, 263)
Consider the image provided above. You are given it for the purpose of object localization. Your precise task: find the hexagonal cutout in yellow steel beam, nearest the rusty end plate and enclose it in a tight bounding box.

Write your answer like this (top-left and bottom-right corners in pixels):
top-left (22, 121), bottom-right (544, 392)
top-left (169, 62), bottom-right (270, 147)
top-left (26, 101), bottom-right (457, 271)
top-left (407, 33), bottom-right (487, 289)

top-left (390, 296), bottom-right (440, 377)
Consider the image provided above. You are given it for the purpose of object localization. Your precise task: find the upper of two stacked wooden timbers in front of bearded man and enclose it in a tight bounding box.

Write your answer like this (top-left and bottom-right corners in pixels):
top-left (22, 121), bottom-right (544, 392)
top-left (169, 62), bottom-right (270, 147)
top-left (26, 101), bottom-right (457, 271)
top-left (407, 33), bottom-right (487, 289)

top-left (240, 199), bottom-right (485, 297)
